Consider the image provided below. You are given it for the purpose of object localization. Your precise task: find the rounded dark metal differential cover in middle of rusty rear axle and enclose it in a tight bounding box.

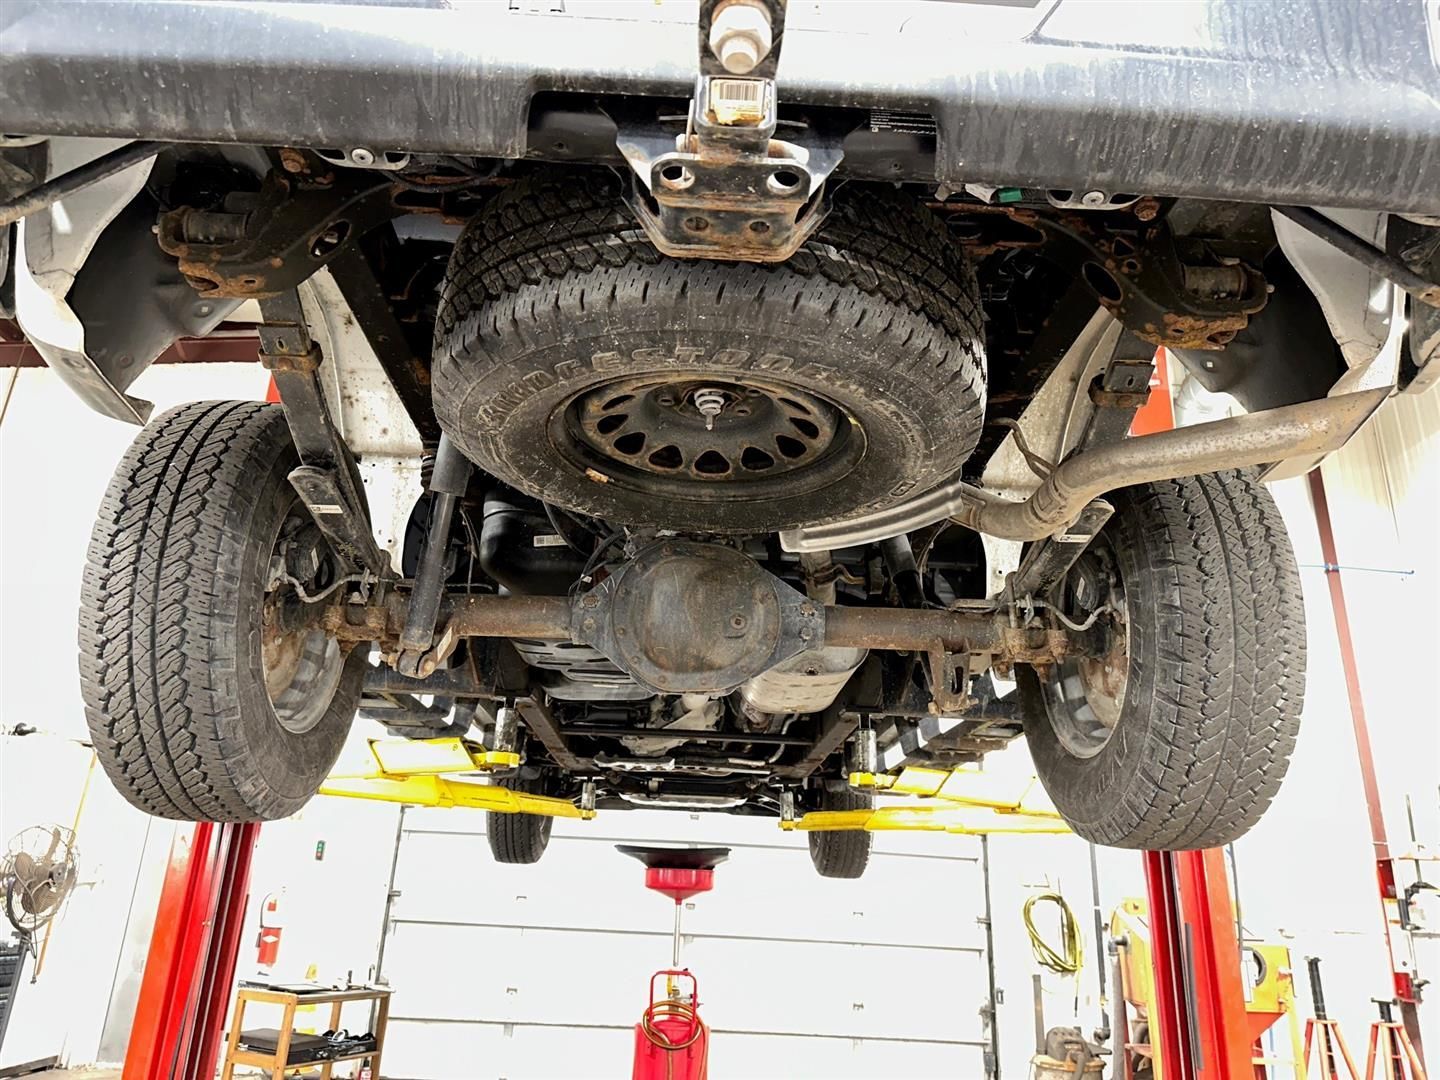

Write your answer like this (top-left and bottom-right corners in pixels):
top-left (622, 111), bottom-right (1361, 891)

top-left (572, 540), bottom-right (825, 694)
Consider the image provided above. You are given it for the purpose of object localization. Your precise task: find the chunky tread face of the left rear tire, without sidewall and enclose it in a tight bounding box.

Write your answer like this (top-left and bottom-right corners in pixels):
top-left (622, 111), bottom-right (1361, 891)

top-left (79, 402), bottom-right (351, 821)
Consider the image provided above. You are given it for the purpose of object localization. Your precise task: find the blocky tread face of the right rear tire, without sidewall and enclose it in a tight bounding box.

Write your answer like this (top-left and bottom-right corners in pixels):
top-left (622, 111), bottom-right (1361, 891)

top-left (1036, 471), bottom-right (1305, 850)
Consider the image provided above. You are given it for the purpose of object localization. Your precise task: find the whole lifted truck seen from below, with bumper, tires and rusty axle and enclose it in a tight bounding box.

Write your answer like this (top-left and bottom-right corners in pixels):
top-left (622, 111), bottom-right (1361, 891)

top-left (0, 0), bottom-right (1440, 876)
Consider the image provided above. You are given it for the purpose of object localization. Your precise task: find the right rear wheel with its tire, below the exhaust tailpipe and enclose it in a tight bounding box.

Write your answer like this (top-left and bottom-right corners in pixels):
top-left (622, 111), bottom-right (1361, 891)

top-left (1017, 471), bottom-right (1305, 850)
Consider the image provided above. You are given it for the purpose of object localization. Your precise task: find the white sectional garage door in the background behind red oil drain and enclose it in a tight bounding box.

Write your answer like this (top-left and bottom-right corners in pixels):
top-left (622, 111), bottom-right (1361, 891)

top-left (384, 809), bottom-right (989, 1080)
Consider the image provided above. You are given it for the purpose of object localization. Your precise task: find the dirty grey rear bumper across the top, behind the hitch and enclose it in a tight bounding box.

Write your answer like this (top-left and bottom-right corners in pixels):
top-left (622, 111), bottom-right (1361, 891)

top-left (0, 0), bottom-right (1440, 213)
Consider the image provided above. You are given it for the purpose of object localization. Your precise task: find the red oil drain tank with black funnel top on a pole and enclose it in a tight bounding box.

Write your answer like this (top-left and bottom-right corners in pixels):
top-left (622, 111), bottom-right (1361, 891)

top-left (616, 844), bottom-right (730, 1080)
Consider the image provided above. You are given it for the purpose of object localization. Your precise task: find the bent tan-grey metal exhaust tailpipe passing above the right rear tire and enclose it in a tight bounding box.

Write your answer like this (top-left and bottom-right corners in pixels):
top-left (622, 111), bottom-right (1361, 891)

top-left (780, 386), bottom-right (1390, 552)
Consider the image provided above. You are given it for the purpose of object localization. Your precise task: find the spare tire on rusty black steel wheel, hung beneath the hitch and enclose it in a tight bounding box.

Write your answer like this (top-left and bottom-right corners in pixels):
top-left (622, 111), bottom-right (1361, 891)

top-left (433, 173), bottom-right (985, 533)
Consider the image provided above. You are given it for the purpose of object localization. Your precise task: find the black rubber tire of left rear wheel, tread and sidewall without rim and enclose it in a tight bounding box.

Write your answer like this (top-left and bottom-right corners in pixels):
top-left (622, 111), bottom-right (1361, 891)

top-left (79, 402), bottom-right (367, 821)
